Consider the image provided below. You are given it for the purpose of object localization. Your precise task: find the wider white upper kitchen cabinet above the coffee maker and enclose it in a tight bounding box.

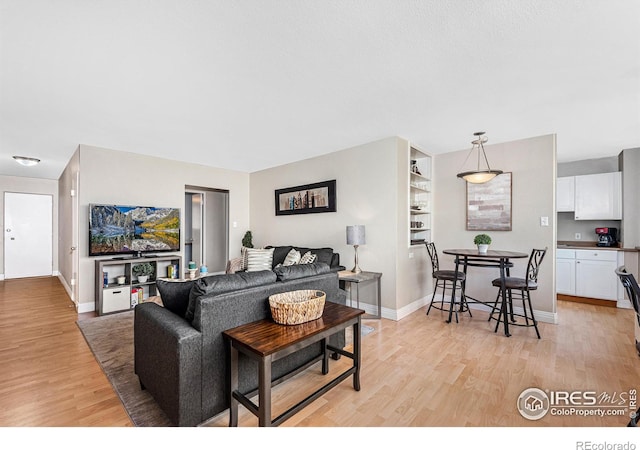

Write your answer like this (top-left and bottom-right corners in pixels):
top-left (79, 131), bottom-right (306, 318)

top-left (573, 172), bottom-right (622, 220)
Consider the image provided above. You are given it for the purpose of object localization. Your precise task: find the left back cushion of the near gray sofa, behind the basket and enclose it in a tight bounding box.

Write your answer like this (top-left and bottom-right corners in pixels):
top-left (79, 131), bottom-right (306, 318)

top-left (184, 270), bottom-right (277, 322)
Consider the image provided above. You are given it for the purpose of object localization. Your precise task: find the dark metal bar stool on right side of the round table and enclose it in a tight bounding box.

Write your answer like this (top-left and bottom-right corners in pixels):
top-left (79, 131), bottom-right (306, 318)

top-left (489, 247), bottom-right (547, 339)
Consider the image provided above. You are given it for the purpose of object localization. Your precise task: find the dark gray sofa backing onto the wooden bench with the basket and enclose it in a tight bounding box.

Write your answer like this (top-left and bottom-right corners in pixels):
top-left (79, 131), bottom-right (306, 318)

top-left (134, 262), bottom-right (346, 426)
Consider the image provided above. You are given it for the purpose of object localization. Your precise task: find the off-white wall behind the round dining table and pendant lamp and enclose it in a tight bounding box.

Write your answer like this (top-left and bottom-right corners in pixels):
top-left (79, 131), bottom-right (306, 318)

top-left (433, 135), bottom-right (556, 321)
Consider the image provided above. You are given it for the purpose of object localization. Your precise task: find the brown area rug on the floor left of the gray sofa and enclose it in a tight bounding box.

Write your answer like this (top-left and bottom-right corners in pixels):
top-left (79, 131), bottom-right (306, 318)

top-left (77, 311), bottom-right (171, 427)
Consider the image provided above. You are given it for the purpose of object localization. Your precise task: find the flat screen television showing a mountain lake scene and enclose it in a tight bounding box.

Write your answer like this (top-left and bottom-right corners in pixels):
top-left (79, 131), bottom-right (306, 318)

top-left (89, 204), bottom-right (180, 256)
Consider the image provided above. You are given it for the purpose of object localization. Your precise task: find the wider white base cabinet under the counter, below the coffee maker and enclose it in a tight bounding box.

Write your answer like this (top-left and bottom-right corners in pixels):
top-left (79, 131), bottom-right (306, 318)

top-left (575, 250), bottom-right (619, 300)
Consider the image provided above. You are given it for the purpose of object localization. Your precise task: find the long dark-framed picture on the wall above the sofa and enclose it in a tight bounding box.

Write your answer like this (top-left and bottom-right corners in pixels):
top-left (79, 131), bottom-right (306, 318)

top-left (275, 180), bottom-right (337, 216)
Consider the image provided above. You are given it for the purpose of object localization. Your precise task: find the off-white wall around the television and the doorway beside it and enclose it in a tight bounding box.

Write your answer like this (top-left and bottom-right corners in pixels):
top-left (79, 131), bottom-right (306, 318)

top-left (69, 145), bottom-right (249, 312)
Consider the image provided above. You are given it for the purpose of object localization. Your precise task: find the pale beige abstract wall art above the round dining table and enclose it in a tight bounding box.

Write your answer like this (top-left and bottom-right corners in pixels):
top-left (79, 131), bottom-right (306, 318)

top-left (467, 172), bottom-right (511, 231)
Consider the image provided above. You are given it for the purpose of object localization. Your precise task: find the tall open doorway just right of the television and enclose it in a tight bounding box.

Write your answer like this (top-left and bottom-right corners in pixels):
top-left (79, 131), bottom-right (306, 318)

top-left (184, 186), bottom-right (229, 274)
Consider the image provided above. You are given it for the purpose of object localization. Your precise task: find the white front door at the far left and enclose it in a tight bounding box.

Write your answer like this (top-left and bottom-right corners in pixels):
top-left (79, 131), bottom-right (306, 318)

top-left (4, 192), bottom-right (53, 279)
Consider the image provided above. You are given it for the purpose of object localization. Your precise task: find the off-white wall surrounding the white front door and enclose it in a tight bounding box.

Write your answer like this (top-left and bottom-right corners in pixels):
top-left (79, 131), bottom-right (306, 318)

top-left (0, 175), bottom-right (58, 280)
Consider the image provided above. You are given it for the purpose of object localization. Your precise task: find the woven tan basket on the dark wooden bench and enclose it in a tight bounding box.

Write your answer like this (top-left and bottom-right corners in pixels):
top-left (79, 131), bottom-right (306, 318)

top-left (269, 289), bottom-right (327, 325)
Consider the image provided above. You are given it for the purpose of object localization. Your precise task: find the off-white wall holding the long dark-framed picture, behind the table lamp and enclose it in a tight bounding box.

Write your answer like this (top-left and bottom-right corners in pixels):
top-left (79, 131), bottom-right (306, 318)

top-left (251, 137), bottom-right (425, 318)
